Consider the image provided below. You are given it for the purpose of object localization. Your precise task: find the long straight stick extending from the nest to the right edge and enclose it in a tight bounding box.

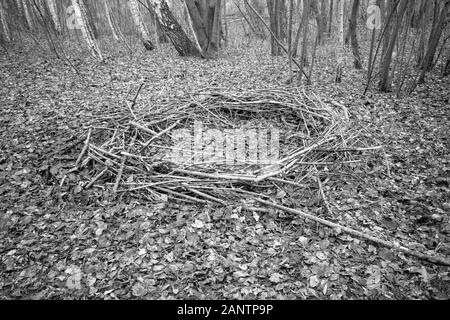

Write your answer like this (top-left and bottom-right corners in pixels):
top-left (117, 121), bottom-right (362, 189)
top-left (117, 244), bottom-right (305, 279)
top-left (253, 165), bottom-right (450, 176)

top-left (255, 198), bottom-right (450, 266)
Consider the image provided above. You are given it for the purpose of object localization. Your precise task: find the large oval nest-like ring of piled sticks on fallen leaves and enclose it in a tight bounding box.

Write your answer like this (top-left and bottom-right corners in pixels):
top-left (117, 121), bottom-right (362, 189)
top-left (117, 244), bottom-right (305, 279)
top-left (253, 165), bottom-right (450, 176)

top-left (77, 88), bottom-right (378, 205)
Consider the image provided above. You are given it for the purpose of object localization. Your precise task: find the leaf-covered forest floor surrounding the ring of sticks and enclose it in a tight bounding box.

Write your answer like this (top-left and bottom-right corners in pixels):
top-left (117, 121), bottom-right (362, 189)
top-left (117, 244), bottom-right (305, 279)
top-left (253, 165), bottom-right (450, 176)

top-left (0, 41), bottom-right (450, 299)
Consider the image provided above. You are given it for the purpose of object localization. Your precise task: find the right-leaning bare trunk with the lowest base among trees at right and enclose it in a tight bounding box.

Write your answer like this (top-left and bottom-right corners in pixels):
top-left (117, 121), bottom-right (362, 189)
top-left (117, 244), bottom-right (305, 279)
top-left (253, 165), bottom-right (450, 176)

top-left (379, 0), bottom-right (408, 92)
